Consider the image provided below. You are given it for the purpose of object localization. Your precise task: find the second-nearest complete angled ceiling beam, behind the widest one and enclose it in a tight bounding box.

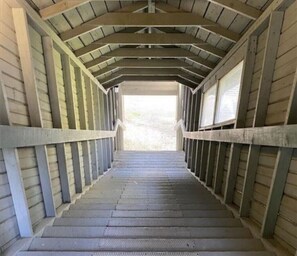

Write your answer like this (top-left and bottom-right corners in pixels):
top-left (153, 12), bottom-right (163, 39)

top-left (74, 32), bottom-right (226, 57)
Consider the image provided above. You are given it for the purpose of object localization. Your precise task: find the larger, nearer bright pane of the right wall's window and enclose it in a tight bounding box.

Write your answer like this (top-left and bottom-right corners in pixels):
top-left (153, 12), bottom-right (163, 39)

top-left (215, 62), bottom-right (243, 124)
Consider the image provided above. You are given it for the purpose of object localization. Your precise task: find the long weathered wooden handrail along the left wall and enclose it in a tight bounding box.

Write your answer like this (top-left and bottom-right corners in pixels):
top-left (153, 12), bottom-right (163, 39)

top-left (0, 119), bottom-right (126, 149)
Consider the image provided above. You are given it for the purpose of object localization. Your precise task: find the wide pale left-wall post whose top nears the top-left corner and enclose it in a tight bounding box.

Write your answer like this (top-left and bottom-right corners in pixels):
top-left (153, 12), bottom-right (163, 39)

top-left (12, 8), bottom-right (56, 217)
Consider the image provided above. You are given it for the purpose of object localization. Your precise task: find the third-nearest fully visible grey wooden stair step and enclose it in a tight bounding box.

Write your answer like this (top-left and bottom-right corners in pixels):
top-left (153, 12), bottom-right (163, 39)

top-left (54, 218), bottom-right (242, 227)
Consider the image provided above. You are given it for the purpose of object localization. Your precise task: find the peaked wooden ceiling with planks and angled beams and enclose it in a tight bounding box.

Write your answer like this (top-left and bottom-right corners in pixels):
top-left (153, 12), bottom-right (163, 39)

top-left (27, 0), bottom-right (271, 88)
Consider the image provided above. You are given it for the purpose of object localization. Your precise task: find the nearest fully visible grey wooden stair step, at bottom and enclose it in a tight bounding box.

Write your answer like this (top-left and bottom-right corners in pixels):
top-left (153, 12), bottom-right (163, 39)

top-left (29, 238), bottom-right (264, 252)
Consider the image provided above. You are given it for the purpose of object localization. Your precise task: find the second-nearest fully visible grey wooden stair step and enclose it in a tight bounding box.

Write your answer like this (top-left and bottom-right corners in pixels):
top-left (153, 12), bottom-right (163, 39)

top-left (42, 226), bottom-right (252, 238)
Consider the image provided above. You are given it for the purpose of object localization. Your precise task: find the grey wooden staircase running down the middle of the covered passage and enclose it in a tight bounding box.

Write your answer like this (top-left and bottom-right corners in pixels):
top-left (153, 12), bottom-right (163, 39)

top-left (18, 151), bottom-right (274, 256)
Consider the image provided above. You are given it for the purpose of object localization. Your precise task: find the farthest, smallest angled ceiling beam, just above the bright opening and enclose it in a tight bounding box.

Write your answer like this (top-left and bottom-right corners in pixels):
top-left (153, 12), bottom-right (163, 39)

top-left (104, 76), bottom-right (197, 89)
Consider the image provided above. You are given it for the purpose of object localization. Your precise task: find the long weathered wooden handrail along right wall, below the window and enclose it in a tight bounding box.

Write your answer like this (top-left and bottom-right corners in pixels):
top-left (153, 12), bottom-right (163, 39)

top-left (175, 120), bottom-right (297, 148)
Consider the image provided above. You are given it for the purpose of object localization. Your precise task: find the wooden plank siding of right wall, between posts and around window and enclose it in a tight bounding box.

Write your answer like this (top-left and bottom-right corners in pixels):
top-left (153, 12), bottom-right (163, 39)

top-left (184, 1), bottom-right (297, 255)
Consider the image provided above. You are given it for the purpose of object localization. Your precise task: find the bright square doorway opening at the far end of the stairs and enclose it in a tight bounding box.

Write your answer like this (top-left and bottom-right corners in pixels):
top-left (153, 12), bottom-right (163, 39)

top-left (123, 95), bottom-right (177, 150)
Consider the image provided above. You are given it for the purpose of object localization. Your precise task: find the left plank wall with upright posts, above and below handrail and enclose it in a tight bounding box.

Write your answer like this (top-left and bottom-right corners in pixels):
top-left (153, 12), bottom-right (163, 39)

top-left (0, 0), bottom-right (117, 254)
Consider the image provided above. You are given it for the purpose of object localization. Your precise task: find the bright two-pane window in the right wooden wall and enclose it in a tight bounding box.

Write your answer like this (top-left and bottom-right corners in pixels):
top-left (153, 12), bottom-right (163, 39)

top-left (200, 61), bottom-right (243, 127)
